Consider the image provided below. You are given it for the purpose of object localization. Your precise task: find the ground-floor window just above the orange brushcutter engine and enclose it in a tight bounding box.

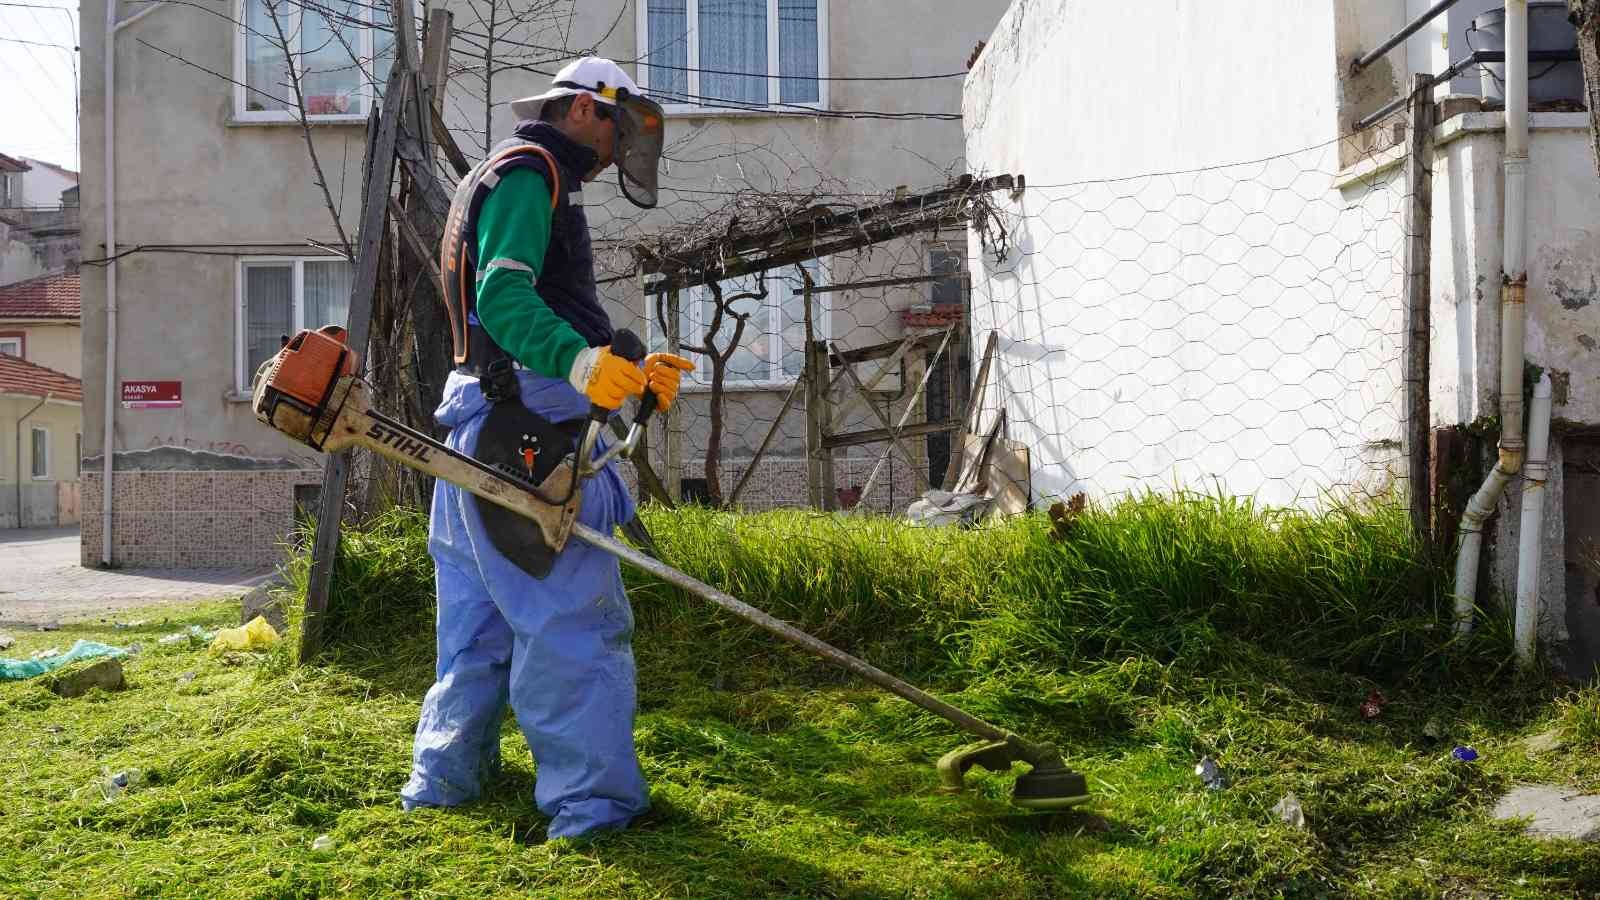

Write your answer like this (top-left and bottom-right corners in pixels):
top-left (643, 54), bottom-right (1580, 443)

top-left (235, 258), bottom-right (355, 394)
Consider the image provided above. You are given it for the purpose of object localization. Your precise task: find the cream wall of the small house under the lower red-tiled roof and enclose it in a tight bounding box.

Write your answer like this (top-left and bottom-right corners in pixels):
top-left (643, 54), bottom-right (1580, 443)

top-left (0, 396), bottom-right (82, 528)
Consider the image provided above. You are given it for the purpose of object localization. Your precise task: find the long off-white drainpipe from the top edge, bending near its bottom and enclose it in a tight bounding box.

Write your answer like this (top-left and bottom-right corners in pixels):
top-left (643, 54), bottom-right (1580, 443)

top-left (1456, 0), bottom-right (1528, 634)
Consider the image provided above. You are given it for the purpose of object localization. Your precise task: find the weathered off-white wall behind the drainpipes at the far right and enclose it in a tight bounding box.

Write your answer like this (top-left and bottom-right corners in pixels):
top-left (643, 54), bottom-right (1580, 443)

top-left (1430, 112), bottom-right (1600, 666)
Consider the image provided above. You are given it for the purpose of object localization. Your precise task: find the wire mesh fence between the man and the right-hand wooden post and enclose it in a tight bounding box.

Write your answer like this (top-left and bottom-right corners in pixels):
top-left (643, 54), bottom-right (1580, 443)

top-left (595, 122), bottom-right (1410, 512)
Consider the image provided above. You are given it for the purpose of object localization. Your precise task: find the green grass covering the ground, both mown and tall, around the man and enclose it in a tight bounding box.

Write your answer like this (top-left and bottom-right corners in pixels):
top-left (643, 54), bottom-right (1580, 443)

top-left (0, 496), bottom-right (1600, 898)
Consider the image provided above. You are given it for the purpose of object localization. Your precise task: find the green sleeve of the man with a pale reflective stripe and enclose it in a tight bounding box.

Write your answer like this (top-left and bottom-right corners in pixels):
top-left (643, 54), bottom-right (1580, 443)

top-left (477, 168), bottom-right (589, 378)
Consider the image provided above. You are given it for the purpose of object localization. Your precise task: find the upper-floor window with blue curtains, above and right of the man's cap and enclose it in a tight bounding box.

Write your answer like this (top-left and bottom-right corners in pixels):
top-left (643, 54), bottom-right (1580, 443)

top-left (638, 0), bottom-right (827, 112)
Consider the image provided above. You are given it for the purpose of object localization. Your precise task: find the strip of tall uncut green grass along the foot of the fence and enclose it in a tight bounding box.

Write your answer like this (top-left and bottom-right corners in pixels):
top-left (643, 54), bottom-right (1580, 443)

top-left (293, 493), bottom-right (1510, 682)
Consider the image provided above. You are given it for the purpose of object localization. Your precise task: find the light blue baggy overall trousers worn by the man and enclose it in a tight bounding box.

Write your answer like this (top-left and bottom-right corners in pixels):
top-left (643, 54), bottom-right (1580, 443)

top-left (402, 365), bottom-right (650, 838)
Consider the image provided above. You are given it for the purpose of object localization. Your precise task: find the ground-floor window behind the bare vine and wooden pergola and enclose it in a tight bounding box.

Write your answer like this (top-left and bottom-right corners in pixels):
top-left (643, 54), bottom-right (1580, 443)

top-left (648, 259), bottom-right (829, 388)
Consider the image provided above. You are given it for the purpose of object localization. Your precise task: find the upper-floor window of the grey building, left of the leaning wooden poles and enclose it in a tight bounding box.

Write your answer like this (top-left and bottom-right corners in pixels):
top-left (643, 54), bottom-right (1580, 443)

top-left (234, 0), bottom-right (395, 122)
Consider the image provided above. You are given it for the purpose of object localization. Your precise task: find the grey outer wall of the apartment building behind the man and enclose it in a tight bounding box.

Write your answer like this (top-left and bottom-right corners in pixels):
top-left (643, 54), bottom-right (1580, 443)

top-left (80, 0), bottom-right (1005, 562)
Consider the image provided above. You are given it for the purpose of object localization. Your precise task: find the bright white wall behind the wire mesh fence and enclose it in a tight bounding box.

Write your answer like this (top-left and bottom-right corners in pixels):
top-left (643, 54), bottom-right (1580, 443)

top-left (963, 2), bottom-right (1402, 503)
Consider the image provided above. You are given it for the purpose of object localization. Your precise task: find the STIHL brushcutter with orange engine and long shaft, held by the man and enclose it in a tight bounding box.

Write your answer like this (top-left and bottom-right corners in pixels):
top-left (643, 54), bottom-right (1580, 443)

top-left (251, 327), bottom-right (1088, 810)
